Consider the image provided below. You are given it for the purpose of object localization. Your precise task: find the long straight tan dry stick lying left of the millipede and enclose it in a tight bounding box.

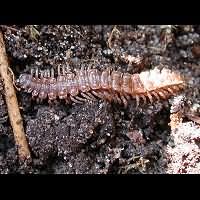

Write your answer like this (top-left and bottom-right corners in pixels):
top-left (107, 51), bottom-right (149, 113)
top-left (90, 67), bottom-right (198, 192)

top-left (0, 31), bottom-right (31, 160)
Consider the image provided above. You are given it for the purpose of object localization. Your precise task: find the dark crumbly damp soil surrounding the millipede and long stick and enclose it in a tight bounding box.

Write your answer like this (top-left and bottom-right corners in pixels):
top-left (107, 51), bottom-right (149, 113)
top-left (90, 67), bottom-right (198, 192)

top-left (0, 25), bottom-right (200, 174)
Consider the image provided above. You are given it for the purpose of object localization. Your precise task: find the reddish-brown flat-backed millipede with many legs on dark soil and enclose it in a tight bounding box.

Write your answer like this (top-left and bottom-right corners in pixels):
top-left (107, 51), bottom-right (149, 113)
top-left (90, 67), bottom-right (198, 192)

top-left (16, 67), bottom-right (185, 107)
